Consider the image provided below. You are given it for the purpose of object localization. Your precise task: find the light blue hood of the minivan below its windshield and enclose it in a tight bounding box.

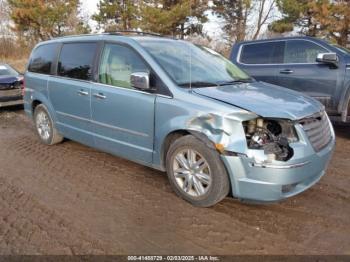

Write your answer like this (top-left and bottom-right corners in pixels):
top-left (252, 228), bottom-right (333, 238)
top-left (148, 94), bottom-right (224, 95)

top-left (193, 82), bottom-right (324, 120)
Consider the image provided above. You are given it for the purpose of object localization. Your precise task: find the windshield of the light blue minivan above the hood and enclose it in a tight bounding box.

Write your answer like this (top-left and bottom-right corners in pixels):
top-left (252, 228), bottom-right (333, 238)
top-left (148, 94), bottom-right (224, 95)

top-left (141, 40), bottom-right (251, 87)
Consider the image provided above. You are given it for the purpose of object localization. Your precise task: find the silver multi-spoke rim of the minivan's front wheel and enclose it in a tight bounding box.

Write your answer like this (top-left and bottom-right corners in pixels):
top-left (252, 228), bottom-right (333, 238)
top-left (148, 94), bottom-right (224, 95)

top-left (173, 149), bottom-right (212, 197)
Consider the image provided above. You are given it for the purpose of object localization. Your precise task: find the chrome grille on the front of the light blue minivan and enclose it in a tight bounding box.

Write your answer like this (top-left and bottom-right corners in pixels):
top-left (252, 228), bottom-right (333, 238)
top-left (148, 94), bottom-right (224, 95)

top-left (299, 112), bottom-right (332, 152)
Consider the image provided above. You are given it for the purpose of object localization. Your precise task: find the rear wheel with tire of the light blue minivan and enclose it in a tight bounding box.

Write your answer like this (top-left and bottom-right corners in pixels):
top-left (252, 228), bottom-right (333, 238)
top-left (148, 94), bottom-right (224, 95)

top-left (34, 104), bottom-right (63, 145)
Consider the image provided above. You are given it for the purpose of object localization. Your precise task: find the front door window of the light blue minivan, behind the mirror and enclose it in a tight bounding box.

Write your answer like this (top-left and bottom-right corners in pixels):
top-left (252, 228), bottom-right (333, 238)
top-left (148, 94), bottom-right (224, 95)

top-left (99, 44), bottom-right (150, 88)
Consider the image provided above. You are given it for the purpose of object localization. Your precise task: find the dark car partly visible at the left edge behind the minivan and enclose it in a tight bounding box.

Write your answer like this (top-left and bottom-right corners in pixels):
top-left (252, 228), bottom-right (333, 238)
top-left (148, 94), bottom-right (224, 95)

top-left (0, 64), bottom-right (23, 107)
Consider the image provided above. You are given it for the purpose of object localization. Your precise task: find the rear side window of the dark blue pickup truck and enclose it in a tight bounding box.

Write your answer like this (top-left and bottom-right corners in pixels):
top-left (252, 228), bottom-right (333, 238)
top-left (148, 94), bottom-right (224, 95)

top-left (240, 41), bottom-right (284, 64)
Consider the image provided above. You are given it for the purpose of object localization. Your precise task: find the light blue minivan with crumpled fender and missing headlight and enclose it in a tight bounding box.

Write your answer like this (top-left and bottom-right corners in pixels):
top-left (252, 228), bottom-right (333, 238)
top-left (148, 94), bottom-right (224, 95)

top-left (24, 34), bottom-right (335, 206)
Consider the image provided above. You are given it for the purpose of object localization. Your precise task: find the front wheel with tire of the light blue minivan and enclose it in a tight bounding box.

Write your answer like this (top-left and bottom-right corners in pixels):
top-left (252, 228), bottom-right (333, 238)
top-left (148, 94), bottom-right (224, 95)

top-left (166, 135), bottom-right (230, 207)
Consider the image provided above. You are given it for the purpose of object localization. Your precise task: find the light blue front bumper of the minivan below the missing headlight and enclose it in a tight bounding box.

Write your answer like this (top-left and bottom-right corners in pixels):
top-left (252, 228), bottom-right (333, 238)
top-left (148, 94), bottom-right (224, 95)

top-left (222, 125), bottom-right (335, 202)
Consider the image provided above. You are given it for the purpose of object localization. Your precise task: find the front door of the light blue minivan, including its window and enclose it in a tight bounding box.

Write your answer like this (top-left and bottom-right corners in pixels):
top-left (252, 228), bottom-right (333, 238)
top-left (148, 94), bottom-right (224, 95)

top-left (91, 43), bottom-right (156, 163)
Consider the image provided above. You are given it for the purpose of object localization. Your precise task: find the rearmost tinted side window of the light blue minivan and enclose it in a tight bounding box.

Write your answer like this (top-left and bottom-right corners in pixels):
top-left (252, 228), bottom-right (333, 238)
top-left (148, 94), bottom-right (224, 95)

top-left (28, 44), bottom-right (58, 75)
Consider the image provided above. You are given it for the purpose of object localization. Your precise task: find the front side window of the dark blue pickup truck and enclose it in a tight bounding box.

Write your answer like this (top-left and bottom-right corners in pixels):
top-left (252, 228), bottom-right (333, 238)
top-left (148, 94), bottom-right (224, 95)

top-left (284, 40), bottom-right (328, 64)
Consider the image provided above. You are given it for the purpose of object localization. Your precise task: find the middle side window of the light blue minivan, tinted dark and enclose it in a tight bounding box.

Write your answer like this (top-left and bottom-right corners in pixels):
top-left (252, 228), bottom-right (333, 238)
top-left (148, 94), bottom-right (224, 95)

top-left (58, 43), bottom-right (97, 80)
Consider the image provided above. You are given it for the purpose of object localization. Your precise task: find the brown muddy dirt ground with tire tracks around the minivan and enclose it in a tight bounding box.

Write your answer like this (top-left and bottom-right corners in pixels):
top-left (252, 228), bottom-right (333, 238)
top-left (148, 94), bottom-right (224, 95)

top-left (0, 106), bottom-right (350, 255)
